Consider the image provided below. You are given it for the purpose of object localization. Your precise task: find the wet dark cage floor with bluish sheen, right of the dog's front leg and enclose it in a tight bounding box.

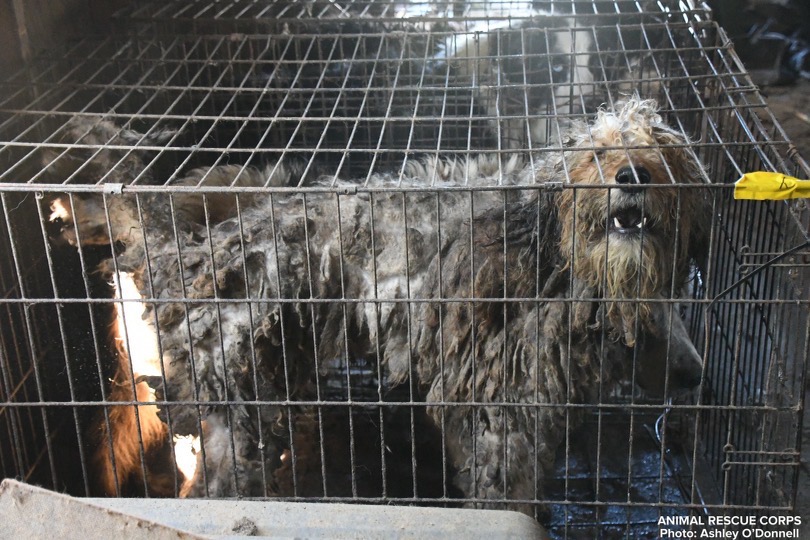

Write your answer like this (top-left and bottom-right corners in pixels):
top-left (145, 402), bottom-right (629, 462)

top-left (548, 413), bottom-right (696, 538)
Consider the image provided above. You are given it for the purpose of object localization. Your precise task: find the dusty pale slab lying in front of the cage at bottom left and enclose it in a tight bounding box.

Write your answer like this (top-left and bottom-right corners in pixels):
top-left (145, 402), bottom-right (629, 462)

top-left (0, 479), bottom-right (548, 540)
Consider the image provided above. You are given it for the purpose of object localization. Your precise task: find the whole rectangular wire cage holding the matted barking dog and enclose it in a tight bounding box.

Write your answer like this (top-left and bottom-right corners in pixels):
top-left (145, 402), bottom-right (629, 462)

top-left (0, 0), bottom-right (810, 538)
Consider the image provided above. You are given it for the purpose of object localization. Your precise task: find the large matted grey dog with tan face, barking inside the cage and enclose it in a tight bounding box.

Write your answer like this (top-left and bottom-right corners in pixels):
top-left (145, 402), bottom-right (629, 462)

top-left (49, 96), bottom-right (708, 515)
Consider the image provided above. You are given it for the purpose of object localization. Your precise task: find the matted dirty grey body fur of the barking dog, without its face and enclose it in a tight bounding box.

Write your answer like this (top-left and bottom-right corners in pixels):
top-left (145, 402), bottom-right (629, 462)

top-left (49, 102), bottom-right (701, 513)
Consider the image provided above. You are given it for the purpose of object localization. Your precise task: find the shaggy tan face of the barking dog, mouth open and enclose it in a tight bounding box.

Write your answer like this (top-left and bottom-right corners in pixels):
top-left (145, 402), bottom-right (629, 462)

top-left (559, 99), bottom-right (706, 346)
